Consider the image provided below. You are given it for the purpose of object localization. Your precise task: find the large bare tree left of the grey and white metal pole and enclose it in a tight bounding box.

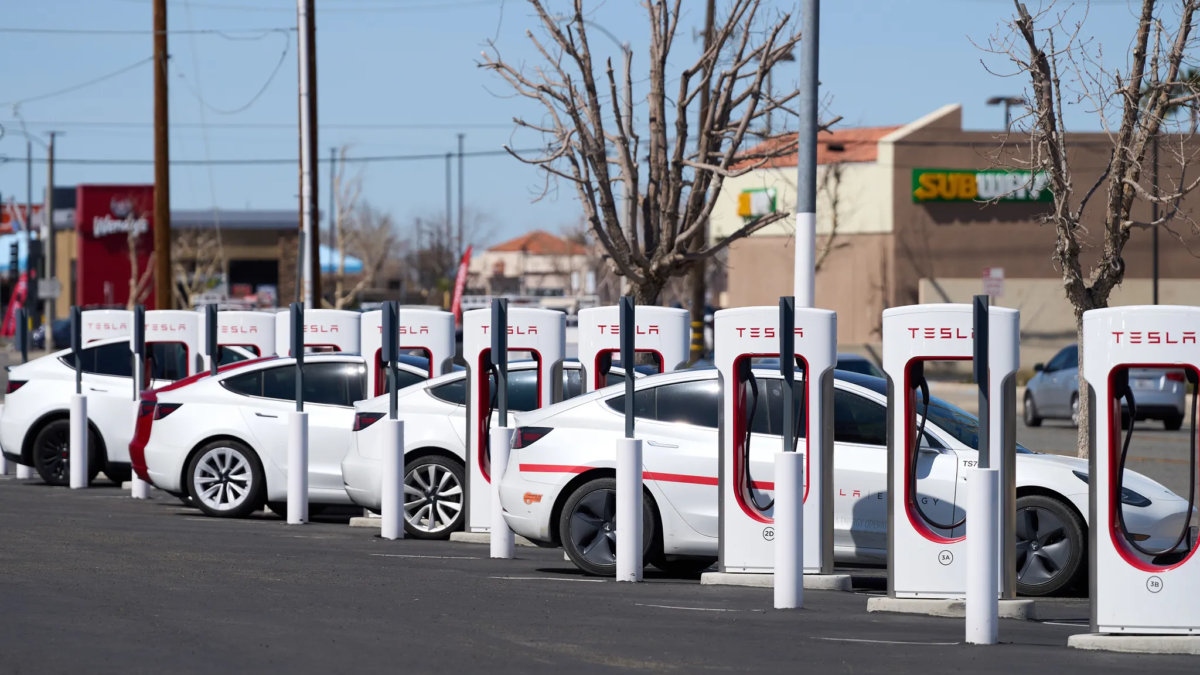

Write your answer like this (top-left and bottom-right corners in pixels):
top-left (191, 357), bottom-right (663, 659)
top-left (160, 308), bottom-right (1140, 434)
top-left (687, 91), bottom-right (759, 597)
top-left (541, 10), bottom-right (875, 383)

top-left (480, 0), bottom-right (836, 304)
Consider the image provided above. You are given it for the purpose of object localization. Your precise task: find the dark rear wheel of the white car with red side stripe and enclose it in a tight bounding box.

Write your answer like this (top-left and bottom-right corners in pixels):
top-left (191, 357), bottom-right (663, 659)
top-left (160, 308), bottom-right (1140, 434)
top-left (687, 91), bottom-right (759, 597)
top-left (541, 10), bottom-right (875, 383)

top-left (558, 478), bottom-right (658, 577)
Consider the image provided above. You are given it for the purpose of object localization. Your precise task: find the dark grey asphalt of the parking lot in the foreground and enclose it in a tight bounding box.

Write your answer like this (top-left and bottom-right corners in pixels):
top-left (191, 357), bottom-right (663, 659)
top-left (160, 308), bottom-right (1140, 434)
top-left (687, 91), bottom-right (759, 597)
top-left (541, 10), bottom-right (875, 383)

top-left (0, 478), bottom-right (1198, 675)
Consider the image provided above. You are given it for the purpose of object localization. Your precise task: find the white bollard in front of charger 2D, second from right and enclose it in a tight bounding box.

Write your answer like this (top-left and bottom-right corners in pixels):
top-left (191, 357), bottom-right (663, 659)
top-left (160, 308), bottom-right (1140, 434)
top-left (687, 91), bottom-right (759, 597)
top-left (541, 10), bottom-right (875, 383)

top-left (774, 452), bottom-right (804, 609)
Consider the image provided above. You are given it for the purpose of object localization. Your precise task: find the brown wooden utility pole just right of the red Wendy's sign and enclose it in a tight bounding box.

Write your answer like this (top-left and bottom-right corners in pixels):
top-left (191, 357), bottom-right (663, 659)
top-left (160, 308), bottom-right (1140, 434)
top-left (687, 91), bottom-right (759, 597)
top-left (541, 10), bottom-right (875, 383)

top-left (154, 0), bottom-right (175, 310)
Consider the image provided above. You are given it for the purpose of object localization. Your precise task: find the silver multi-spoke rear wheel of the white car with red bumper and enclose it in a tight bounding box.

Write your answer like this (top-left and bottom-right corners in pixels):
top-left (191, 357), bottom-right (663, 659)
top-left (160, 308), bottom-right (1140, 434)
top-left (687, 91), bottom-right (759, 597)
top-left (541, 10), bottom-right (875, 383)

top-left (187, 441), bottom-right (266, 518)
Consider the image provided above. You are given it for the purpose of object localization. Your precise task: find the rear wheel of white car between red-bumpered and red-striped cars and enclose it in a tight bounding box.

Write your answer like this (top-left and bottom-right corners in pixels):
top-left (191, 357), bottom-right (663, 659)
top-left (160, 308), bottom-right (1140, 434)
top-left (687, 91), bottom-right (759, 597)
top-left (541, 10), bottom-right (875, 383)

top-left (404, 455), bottom-right (467, 539)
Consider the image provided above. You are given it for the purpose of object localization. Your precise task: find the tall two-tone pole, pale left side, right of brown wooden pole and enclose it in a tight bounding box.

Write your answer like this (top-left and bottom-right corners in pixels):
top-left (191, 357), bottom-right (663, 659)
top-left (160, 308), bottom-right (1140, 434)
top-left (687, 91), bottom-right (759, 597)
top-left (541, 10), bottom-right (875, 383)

top-left (296, 0), bottom-right (320, 310)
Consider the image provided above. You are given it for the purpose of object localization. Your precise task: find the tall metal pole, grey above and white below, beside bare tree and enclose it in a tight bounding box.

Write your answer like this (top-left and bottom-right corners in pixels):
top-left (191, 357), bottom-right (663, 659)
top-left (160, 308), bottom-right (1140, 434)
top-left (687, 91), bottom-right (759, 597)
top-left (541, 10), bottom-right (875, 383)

top-left (796, 0), bottom-right (821, 307)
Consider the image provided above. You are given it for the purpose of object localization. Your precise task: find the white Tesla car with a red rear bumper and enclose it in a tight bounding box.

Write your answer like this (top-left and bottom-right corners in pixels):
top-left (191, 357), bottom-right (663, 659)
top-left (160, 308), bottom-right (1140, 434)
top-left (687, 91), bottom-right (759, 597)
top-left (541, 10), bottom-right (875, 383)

top-left (130, 353), bottom-right (428, 518)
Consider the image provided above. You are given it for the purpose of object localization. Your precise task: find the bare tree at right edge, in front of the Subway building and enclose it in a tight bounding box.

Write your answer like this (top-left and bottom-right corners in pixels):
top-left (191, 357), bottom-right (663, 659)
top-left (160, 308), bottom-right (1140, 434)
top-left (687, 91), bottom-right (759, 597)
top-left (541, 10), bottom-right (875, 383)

top-left (989, 0), bottom-right (1200, 456)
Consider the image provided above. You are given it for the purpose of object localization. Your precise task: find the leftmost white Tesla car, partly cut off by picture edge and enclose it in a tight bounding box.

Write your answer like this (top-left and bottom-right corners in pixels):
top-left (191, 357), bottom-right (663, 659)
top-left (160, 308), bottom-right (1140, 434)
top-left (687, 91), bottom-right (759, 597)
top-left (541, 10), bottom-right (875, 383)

top-left (0, 338), bottom-right (254, 485)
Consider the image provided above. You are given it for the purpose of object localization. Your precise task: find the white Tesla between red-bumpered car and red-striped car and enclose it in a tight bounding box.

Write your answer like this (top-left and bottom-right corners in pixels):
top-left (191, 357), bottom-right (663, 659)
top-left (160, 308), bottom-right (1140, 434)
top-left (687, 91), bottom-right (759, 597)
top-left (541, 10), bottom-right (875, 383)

top-left (342, 362), bottom-right (646, 539)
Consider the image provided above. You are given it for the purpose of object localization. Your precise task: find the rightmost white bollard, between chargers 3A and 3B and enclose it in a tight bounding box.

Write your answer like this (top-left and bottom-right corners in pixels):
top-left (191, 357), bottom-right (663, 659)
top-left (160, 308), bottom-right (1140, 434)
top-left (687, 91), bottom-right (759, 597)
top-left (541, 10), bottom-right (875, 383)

top-left (966, 468), bottom-right (1000, 645)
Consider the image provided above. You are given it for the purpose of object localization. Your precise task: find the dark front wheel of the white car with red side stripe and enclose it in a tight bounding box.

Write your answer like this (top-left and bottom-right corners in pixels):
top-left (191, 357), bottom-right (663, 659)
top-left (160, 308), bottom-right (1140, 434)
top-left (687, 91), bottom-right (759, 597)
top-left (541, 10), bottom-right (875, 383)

top-left (1016, 495), bottom-right (1087, 596)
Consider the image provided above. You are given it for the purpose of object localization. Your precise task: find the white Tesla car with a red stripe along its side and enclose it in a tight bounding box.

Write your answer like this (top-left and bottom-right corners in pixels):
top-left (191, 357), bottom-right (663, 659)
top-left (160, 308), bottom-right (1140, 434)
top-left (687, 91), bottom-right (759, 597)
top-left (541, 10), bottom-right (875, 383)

top-left (500, 370), bottom-right (1195, 595)
